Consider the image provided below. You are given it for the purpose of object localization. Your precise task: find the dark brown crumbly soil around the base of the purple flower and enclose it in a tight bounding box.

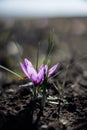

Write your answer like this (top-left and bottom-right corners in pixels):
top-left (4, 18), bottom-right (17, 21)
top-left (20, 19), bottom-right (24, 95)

top-left (0, 61), bottom-right (87, 130)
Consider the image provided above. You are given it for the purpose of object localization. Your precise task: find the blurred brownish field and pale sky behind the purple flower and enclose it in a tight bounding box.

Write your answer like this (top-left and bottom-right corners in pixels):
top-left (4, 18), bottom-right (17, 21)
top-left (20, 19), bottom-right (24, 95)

top-left (0, 0), bottom-right (87, 83)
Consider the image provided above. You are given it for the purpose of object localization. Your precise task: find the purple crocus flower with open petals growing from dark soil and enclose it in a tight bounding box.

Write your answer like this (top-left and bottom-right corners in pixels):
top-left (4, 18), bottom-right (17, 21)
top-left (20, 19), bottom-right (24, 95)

top-left (20, 58), bottom-right (58, 84)
